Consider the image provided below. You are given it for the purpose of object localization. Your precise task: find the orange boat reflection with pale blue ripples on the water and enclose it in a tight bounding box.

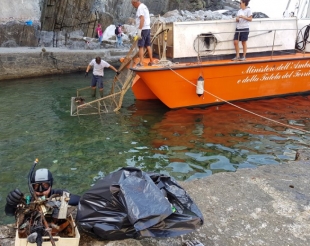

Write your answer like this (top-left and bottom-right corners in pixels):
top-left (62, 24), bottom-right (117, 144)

top-left (137, 96), bottom-right (310, 180)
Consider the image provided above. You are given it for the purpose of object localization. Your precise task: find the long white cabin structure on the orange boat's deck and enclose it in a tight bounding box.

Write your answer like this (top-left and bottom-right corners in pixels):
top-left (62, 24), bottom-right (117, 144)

top-left (152, 1), bottom-right (310, 61)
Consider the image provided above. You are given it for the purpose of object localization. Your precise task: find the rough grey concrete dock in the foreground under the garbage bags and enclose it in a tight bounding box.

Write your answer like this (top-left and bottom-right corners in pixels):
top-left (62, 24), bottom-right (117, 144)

top-left (0, 150), bottom-right (310, 246)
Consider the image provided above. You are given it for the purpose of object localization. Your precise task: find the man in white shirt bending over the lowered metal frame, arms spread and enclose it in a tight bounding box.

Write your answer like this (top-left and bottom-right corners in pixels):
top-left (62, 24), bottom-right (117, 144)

top-left (85, 56), bottom-right (119, 97)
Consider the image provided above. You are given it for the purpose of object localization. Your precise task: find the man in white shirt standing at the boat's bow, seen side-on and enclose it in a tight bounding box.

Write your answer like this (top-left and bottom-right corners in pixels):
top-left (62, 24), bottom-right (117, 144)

top-left (131, 0), bottom-right (153, 66)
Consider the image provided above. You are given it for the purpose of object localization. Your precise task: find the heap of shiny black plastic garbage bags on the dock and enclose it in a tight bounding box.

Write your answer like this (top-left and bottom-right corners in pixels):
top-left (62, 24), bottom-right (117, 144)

top-left (76, 167), bottom-right (203, 240)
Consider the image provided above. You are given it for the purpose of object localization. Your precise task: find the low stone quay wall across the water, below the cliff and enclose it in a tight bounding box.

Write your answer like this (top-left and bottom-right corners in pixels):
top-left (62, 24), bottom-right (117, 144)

top-left (0, 47), bottom-right (127, 81)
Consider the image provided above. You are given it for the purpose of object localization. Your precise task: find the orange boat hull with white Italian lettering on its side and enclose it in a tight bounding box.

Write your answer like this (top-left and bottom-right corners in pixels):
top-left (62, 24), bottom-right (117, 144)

top-left (133, 54), bottom-right (310, 108)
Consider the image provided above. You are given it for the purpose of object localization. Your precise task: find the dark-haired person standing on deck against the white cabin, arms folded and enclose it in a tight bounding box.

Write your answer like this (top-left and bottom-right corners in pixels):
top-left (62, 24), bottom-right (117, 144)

top-left (232, 0), bottom-right (252, 61)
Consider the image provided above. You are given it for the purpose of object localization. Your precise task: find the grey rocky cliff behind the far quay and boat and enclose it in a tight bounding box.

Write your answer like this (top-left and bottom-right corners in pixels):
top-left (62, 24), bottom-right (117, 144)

top-left (0, 0), bottom-right (232, 47)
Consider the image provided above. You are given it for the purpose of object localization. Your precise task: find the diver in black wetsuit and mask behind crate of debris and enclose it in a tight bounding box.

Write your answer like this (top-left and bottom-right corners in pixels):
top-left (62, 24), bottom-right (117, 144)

top-left (5, 168), bottom-right (80, 216)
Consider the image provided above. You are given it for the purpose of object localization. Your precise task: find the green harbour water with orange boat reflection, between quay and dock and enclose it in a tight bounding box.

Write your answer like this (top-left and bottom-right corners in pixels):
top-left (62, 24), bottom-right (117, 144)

top-left (0, 70), bottom-right (310, 224)
